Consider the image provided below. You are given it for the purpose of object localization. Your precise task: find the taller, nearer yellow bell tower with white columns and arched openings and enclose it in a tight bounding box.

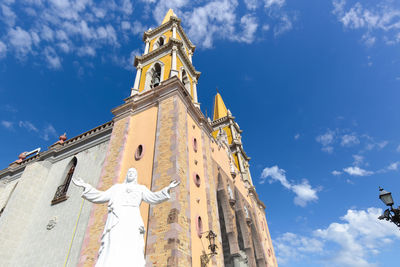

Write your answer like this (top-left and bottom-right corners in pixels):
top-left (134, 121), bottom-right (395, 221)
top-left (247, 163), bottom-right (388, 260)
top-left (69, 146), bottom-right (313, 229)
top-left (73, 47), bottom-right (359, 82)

top-left (131, 9), bottom-right (200, 107)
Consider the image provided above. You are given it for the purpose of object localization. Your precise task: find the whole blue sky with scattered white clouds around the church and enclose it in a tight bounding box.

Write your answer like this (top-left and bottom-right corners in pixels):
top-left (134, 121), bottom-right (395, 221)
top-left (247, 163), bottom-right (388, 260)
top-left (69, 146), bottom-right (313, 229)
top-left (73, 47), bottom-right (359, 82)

top-left (0, 0), bottom-right (400, 266)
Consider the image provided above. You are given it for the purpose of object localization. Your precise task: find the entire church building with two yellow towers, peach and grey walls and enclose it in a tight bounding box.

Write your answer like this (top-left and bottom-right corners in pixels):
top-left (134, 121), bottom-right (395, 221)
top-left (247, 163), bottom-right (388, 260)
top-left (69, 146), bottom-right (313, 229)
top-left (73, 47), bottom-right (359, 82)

top-left (0, 10), bottom-right (277, 267)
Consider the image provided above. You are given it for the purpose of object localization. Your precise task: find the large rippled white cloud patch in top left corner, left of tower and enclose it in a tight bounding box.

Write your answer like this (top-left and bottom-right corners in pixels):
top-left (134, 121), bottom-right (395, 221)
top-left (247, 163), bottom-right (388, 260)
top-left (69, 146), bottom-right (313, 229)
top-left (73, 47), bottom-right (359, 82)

top-left (0, 0), bottom-right (124, 69)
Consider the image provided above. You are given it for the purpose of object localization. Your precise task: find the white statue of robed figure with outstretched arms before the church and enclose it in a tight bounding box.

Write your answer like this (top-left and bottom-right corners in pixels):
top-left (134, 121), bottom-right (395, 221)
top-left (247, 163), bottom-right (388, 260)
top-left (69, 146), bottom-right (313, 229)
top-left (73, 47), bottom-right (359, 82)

top-left (72, 168), bottom-right (179, 267)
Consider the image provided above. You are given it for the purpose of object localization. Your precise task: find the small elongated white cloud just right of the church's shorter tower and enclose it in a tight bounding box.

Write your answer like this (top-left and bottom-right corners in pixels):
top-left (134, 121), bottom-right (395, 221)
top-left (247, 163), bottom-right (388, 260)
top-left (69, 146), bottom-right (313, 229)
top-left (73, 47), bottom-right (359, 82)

top-left (260, 165), bottom-right (318, 207)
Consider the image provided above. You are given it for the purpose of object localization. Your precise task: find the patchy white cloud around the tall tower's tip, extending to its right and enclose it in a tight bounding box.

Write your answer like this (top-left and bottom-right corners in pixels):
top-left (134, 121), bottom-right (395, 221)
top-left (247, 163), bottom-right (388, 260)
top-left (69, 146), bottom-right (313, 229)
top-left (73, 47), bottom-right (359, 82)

top-left (153, 0), bottom-right (292, 48)
